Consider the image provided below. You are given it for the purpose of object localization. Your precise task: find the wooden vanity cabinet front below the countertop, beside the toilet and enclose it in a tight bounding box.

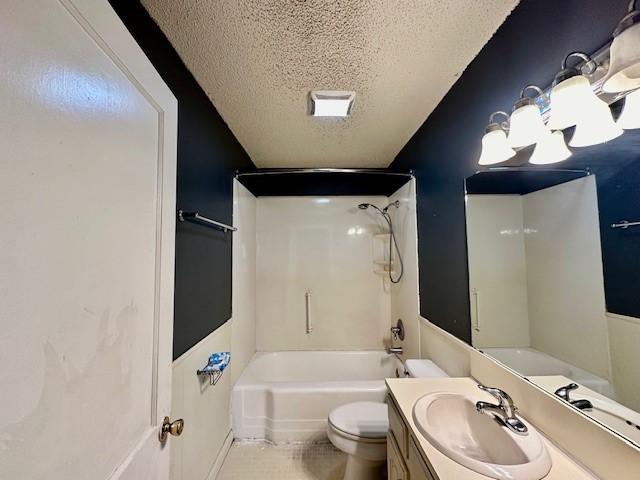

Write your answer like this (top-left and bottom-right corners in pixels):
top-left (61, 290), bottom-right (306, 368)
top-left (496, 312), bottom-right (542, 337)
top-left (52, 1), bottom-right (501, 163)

top-left (387, 397), bottom-right (437, 480)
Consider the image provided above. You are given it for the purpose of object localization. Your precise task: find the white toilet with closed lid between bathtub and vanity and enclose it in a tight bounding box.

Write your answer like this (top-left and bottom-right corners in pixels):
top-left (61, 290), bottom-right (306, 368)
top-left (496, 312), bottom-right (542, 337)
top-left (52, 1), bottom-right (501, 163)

top-left (327, 360), bottom-right (448, 480)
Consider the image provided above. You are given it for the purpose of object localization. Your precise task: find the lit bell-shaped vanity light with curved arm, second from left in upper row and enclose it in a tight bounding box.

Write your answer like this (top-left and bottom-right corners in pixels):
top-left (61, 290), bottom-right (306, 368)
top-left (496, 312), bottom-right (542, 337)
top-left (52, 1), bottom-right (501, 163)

top-left (507, 85), bottom-right (549, 148)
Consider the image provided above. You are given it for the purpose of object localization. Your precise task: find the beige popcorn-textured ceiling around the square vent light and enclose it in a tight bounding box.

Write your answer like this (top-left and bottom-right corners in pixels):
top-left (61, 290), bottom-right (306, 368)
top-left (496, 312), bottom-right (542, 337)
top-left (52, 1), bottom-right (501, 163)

top-left (142, 0), bottom-right (518, 167)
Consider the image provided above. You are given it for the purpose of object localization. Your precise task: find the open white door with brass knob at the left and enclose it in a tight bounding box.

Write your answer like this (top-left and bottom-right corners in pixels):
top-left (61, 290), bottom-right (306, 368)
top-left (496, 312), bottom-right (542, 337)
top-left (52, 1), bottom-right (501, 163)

top-left (0, 0), bottom-right (178, 480)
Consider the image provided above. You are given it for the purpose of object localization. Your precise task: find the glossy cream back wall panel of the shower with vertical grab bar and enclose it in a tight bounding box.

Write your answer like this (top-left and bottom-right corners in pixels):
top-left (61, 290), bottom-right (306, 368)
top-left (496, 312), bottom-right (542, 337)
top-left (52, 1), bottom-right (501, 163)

top-left (256, 196), bottom-right (391, 351)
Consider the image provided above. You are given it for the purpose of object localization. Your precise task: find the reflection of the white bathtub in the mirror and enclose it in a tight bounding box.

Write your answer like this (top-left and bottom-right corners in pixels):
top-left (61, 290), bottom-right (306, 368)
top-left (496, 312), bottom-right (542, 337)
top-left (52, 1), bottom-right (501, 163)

top-left (481, 348), bottom-right (615, 399)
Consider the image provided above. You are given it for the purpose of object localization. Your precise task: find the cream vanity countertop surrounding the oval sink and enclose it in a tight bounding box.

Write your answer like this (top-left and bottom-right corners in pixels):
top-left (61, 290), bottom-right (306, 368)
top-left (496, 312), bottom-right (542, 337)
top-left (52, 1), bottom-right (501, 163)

top-left (386, 378), bottom-right (596, 480)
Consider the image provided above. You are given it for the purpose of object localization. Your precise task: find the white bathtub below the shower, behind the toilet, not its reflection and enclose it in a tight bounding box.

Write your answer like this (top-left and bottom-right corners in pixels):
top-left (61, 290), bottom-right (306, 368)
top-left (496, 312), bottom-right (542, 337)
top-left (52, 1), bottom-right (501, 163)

top-left (231, 351), bottom-right (403, 443)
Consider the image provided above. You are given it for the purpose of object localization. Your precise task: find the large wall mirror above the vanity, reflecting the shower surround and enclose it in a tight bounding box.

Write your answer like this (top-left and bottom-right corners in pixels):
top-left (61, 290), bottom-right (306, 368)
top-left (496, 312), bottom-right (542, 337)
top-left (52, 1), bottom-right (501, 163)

top-left (466, 168), bottom-right (640, 445)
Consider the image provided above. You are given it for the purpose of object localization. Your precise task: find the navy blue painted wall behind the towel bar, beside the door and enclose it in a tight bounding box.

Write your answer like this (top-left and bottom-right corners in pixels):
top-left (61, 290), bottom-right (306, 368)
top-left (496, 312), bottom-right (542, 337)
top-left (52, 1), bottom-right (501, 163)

top-left (110, 0), bottom-right (255, 359)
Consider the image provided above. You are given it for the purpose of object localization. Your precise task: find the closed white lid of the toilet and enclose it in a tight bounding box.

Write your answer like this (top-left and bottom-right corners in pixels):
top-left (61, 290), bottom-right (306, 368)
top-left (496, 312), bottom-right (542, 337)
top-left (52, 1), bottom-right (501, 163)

top-left (329, 402), bottom-right (389, 438)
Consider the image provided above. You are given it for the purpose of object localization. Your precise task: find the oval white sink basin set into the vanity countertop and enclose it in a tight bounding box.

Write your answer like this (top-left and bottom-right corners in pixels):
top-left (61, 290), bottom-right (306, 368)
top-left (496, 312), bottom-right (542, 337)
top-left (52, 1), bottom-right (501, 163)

top-left (413, 392), bottom-right (551, 480)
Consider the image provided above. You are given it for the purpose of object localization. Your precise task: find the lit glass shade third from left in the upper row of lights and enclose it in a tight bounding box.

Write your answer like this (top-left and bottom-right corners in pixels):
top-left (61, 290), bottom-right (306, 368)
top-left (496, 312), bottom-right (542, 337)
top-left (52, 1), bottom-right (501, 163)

top-left (547, 75), bottom-right (600, 130)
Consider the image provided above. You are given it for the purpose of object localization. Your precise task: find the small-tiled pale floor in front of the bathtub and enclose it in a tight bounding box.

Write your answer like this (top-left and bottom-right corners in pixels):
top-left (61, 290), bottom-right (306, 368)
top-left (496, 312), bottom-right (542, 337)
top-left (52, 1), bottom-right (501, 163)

top-left (216, 443), bottom-right (346, 480)
